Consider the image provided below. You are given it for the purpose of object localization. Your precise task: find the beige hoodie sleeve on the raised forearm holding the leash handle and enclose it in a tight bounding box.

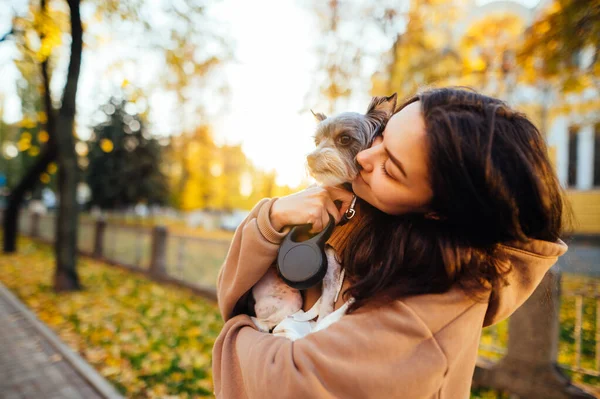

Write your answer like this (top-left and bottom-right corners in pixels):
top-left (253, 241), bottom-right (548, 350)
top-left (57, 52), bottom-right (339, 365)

top-left (217, 198), bottom-right (287, 321)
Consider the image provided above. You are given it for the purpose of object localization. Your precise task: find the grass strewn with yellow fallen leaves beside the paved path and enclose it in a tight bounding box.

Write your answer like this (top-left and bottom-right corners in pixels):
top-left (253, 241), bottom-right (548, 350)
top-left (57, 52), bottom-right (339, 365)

top-left (0, 235), bottom-right (600, 399)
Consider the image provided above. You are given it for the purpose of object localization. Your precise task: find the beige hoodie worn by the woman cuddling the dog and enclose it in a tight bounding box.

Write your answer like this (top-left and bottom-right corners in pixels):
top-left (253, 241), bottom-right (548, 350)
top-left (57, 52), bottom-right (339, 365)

top-left (213, 199), bottom-right (567, 399)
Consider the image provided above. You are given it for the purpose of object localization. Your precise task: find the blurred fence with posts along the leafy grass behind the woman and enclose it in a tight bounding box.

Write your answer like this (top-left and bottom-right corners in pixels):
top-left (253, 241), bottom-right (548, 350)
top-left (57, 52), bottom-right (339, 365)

top-left (5, 212), bottom-right (600, 398)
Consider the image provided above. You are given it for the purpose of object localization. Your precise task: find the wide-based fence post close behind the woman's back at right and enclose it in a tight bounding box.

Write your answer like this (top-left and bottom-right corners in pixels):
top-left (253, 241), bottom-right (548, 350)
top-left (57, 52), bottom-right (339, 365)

top-left (473, 266), bottom-right (593, 399)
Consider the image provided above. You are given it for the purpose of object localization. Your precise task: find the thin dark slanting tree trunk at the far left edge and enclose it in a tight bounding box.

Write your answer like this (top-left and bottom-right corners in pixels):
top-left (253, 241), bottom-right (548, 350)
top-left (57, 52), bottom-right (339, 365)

top-left (3, 26), bottom-right (56, 253)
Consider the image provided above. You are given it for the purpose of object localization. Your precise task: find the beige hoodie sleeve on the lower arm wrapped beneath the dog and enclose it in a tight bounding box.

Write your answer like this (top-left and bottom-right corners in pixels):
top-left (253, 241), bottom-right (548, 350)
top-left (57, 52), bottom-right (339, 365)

top-left (213, 301), bottom-right (448, 399)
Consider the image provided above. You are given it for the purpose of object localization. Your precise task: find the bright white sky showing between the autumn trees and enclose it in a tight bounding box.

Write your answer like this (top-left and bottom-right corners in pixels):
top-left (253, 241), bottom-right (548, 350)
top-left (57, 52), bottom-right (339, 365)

top-left (0, 0), bottom-right (539, 186)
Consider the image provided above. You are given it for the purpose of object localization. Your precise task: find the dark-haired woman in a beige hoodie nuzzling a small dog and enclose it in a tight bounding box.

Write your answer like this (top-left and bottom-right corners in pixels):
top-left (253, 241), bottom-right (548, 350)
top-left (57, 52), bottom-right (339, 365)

top-left (213, 89), bottom-right (567, 398)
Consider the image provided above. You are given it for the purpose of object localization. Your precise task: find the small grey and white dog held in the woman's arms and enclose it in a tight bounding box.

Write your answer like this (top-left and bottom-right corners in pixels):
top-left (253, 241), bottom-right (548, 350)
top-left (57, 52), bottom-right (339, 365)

top-left (252, 94), bottom-right (396, 332)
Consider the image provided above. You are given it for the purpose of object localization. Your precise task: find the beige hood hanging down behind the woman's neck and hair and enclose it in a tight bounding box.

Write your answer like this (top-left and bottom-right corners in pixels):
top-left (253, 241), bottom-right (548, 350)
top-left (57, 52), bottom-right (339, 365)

top-left (483, 239), bottom-right (568, 327)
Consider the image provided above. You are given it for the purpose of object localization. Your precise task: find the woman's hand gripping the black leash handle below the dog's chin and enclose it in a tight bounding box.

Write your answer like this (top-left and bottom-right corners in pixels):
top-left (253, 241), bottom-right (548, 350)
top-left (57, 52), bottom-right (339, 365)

top-left (270, 187), bottom-right (352, 234)
